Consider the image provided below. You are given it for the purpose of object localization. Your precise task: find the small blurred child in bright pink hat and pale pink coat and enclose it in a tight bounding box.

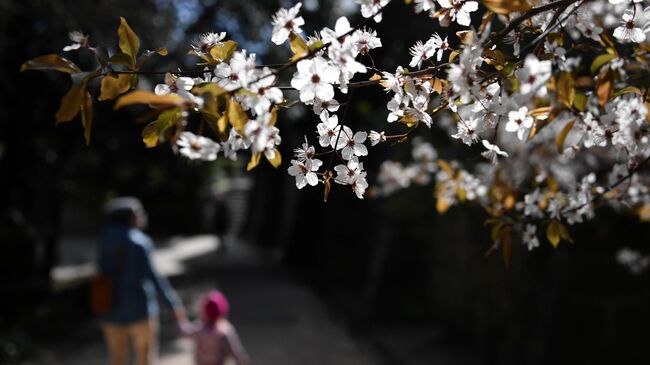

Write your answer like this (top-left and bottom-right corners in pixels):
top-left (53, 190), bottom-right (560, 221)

top-left (181, 291), bottom-right (248, 365)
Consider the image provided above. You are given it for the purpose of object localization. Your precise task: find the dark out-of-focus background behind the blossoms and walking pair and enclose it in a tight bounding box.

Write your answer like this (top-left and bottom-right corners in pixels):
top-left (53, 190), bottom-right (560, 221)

top-left (0, 0), bottom-right (650, 364)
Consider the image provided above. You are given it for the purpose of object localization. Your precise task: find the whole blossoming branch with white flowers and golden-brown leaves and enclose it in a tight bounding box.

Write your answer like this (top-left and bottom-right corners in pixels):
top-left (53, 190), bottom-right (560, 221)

top-left (22, 0), bottom-right (650, 264)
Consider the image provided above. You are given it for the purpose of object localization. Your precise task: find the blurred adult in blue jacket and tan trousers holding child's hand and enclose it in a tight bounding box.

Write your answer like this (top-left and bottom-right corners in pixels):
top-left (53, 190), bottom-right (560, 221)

top-left (99, 197), bottom-right (186, 365)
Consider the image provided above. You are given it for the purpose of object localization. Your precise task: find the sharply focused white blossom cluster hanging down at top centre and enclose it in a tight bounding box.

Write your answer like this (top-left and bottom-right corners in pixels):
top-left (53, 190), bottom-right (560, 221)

top-left (273, 5), bottom-right (387, 198)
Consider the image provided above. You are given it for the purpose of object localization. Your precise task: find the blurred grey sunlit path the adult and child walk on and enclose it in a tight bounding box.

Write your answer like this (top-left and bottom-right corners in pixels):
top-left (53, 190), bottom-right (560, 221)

top-left (25, 236), bottom-right (382, 365)
